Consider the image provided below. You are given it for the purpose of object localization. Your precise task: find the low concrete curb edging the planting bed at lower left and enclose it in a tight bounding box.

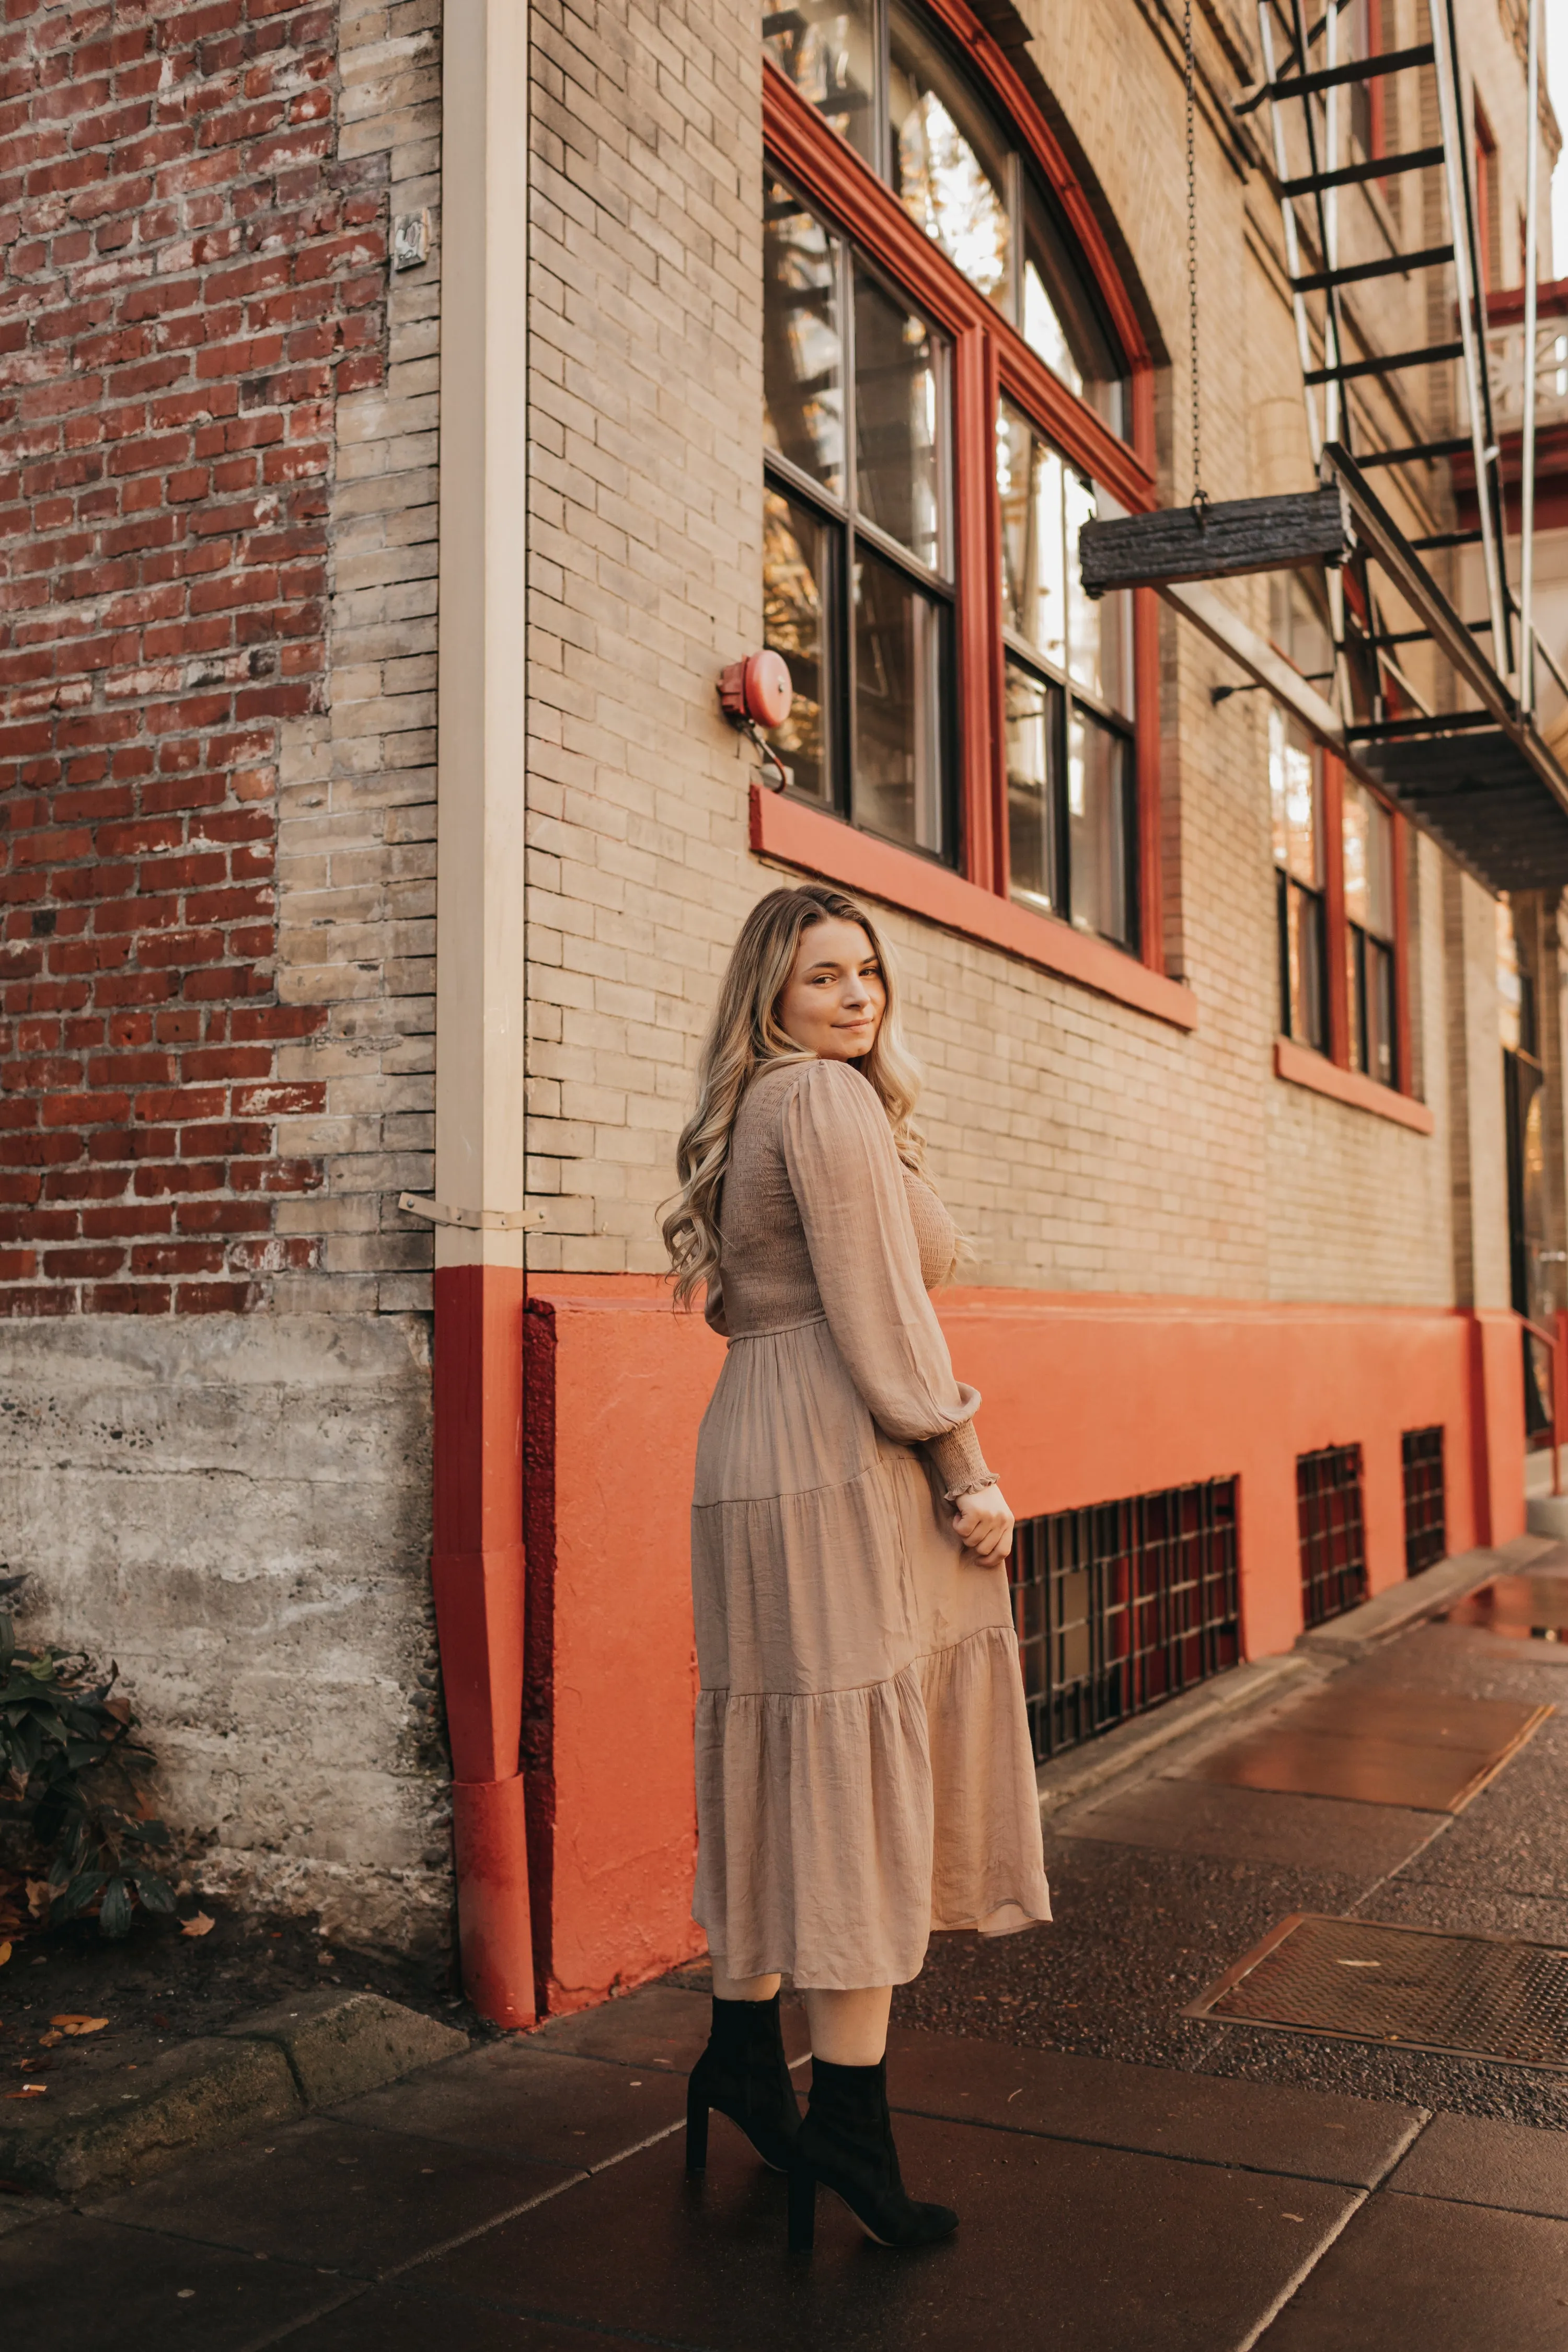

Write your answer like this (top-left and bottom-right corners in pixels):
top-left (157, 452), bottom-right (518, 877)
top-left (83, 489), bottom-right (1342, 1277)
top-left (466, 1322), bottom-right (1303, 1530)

top-left (0, 1990), bottom-right (468, 2197)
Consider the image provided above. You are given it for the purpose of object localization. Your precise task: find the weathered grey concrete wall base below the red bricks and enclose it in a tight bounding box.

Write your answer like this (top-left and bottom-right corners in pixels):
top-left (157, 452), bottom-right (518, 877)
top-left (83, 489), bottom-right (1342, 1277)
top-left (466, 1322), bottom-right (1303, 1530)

top-left (0, 1315), bottom-right (452, 1945)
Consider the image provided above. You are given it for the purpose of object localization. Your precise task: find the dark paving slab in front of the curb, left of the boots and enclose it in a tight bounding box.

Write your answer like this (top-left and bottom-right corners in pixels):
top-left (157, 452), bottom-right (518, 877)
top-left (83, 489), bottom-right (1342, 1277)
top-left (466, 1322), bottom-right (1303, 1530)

top-left (79, 2117), bottom-right (578, 2279)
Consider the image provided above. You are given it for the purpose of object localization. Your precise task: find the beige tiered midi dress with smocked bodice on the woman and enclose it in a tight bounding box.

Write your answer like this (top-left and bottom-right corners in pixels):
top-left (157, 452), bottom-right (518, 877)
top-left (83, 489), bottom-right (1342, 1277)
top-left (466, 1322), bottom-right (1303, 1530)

top-left (691, 1061), bottom-right (1051, 1988)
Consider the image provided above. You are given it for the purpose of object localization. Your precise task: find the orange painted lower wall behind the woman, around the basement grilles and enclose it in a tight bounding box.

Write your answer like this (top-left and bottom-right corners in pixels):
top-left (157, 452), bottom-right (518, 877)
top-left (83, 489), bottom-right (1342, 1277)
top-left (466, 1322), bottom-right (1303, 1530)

top-left (529, 1275), bottom-right (1524, 2011)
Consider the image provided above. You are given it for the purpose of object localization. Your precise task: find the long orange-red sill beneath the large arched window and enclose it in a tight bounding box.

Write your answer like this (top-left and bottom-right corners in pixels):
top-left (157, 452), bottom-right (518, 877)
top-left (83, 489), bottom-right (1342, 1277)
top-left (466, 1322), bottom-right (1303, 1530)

top-left (752, 783), bottom-right (1194, 1035)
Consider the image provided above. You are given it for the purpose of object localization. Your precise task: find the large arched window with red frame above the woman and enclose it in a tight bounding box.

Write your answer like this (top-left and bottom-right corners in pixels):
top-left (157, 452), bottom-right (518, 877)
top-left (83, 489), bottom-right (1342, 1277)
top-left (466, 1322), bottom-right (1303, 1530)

top-left (762, 0), bottom-right (1157, 962)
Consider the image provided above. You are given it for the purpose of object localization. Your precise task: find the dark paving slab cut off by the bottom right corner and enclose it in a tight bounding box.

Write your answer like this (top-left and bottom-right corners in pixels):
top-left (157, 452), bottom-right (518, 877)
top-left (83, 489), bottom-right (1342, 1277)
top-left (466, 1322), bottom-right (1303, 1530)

top-left (1258, 2197), bottom-right (1568, 2352)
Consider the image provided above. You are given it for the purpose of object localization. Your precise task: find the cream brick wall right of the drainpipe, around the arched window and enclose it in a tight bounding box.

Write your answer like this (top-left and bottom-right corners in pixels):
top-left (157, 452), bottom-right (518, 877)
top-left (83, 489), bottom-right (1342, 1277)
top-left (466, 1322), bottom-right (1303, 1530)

top-left (529, 0), bottom-right (1500, 1303)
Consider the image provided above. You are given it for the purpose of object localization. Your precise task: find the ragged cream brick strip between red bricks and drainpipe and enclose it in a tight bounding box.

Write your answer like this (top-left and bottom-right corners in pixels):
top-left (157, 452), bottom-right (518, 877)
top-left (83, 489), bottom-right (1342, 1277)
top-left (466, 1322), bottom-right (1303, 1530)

top-left (273, 0), bottom-right (442, 1315)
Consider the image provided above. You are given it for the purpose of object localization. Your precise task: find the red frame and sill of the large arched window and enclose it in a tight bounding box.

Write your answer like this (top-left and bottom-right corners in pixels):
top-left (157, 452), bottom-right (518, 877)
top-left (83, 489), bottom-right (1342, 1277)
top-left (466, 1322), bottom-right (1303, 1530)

top-left (752, 0), bottom-right (1196, 1028)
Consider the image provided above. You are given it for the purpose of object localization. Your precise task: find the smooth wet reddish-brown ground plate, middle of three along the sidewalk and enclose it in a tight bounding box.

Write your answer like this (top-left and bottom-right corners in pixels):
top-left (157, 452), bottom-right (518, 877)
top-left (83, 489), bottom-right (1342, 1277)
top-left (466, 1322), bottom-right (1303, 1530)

top-left (1182, 1691), bottom-right (1552, 1814)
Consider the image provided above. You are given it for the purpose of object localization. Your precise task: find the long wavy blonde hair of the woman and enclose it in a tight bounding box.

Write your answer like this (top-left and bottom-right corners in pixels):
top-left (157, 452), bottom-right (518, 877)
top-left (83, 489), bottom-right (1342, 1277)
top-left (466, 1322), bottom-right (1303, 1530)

top-left (661, 882), bottom-right (926, 1308)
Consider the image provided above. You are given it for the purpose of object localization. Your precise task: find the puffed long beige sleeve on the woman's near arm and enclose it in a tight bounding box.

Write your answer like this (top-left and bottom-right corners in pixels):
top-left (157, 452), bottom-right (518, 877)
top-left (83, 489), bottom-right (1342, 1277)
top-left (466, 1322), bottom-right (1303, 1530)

top-left (783, 1061), bottom-right (990, 1494)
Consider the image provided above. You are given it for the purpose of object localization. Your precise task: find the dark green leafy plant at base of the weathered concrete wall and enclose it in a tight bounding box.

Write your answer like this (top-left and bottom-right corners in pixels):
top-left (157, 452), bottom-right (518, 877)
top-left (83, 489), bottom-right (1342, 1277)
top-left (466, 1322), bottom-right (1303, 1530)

top-left (0, 1576), bottom-right (174, 1936)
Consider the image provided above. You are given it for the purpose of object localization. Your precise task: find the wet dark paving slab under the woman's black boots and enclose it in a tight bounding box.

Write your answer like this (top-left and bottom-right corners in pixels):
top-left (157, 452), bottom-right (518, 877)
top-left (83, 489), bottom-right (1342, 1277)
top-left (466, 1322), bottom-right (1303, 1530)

top-left (407, 2115), bottom-right (1359, 2352)
